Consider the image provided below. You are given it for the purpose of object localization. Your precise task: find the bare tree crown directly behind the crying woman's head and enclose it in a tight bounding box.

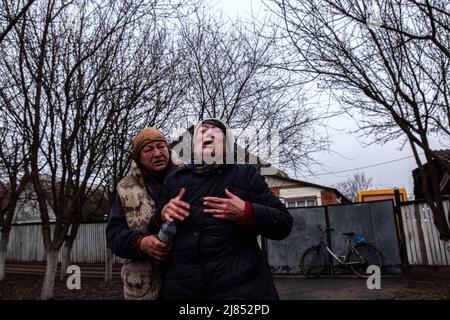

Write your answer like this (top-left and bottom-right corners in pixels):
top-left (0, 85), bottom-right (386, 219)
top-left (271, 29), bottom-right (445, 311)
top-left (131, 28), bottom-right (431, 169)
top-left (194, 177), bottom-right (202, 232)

top-left (180, 8), bottom-right (328, 174)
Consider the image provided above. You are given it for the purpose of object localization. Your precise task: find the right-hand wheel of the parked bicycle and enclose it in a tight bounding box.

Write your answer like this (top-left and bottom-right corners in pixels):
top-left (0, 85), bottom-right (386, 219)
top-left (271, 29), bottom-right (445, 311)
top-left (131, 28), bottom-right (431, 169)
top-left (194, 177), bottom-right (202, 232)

top-left (348, 243), bottom-right (383, 279)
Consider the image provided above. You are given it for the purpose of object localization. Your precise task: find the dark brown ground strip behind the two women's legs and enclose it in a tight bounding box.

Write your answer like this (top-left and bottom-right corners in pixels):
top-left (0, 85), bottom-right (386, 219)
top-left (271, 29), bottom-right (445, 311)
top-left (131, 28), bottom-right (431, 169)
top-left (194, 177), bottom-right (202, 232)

top-left (0, 274), bottom-right (450, 300)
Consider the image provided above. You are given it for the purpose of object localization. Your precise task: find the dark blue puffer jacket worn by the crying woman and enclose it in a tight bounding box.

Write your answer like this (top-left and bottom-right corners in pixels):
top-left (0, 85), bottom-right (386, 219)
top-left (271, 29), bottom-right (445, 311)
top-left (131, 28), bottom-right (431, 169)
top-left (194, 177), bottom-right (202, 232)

top-left (150, 164), bottom-right (292, 300)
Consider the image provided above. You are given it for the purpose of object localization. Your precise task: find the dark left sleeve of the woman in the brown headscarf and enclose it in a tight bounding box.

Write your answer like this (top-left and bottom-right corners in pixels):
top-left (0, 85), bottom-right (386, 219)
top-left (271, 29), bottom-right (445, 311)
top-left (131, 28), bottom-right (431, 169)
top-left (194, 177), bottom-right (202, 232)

top-left (106, 196), bottom-right (142, 259)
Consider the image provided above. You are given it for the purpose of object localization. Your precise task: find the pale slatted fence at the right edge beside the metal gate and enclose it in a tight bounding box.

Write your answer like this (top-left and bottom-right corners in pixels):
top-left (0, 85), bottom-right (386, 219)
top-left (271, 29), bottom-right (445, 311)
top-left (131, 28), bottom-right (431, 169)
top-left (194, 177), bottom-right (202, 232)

top-left (401, 200), bottom-right (450, 266)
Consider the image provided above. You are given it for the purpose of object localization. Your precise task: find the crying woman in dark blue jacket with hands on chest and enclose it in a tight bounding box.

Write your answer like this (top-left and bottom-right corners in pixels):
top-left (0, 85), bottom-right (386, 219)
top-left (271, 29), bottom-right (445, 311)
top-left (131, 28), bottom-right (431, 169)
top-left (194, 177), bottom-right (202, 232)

top-left (150, 119), bottom-right (292, 300)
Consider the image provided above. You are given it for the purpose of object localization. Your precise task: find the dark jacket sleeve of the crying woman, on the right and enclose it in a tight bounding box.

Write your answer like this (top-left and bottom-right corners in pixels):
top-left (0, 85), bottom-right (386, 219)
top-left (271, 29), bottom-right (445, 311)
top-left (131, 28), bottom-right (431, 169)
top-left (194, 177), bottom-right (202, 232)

top-left (249, 166), bottom-right (292, 240)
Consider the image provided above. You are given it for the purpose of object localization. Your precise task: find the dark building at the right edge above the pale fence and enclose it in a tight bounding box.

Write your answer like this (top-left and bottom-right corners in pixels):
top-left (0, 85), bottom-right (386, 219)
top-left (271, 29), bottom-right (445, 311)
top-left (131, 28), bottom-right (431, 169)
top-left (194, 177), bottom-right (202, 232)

top-left (412, 149), bottom-right (450, 200)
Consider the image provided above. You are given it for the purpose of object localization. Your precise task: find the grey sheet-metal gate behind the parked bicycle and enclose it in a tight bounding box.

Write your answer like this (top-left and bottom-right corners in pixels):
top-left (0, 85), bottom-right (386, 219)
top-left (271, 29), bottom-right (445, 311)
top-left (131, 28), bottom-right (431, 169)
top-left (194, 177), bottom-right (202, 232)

top-left (267, 200), bottom-right (402, 274)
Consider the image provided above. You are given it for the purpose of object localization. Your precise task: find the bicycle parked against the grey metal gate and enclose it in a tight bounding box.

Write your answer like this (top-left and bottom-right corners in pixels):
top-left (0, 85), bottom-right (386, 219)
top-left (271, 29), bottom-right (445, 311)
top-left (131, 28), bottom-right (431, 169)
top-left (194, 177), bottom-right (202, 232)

top-left (300, 225), bottom-right (383, 279)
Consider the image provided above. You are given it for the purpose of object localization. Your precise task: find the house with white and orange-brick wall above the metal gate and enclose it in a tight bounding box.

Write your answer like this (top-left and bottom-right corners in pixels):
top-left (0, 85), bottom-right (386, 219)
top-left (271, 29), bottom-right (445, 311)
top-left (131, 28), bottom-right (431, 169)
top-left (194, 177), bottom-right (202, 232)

top-left (265, 170), bottom-right (352, 208)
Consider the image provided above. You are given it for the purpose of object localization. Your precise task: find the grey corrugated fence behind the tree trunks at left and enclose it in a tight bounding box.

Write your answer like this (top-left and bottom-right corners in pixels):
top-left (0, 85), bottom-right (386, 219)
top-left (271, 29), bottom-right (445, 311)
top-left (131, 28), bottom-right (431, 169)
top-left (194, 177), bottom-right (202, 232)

top-left (6, 222), bottom-right (122, 263)
